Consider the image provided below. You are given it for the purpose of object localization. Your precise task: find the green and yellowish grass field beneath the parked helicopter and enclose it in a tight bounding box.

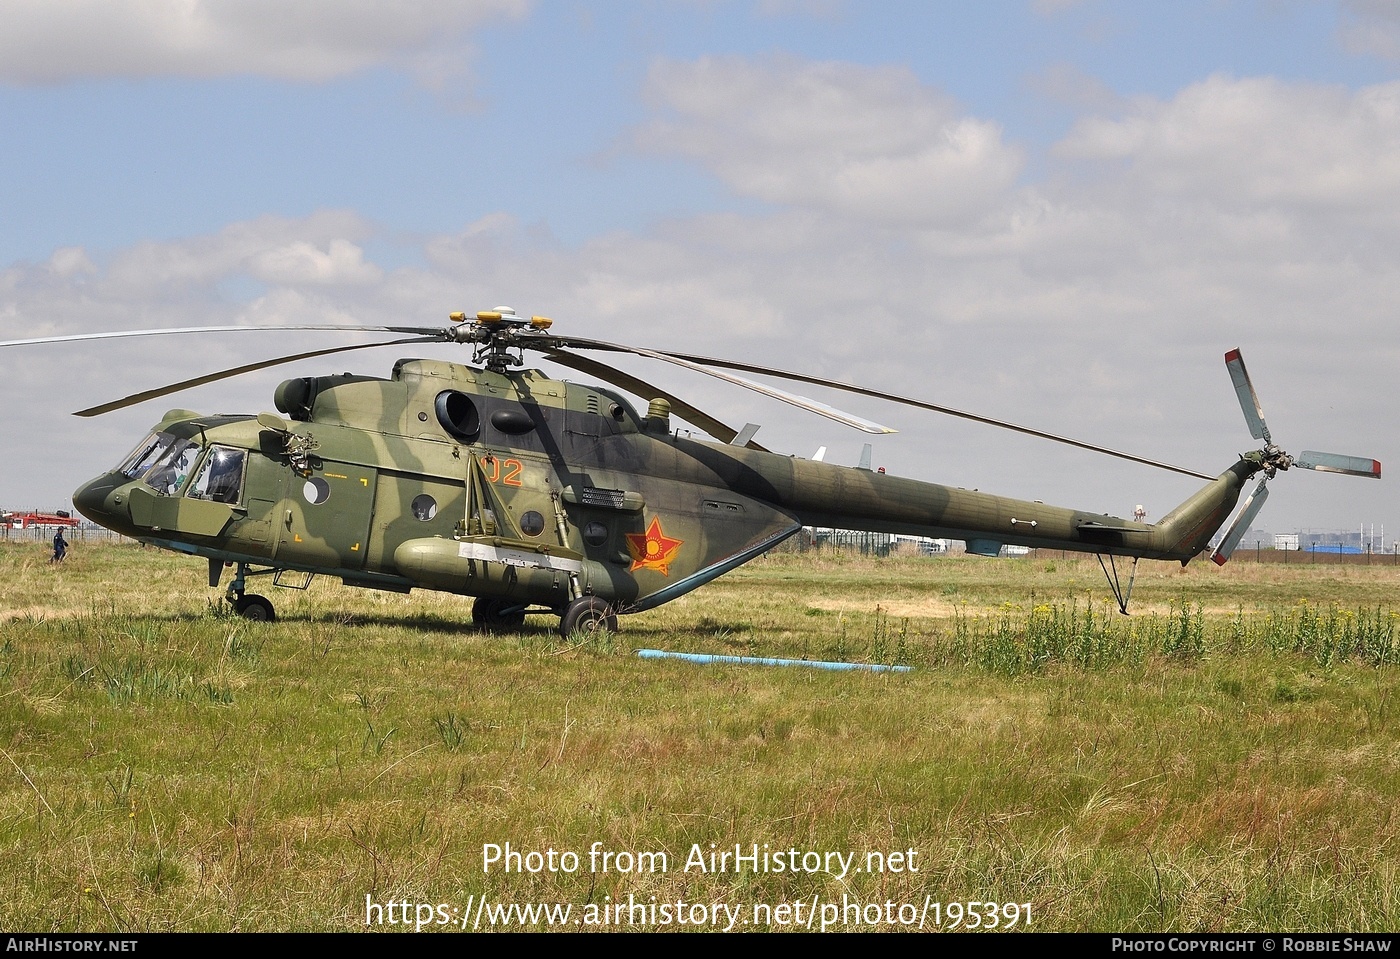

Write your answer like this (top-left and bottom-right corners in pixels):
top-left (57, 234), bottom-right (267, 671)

top-left (0, 545), bottom-right (1400, 931)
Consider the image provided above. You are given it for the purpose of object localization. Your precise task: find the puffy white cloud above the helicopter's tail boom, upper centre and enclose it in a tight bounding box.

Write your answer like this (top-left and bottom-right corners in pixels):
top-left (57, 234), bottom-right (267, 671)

top-left (636, 57), bottom-right (1022, 227)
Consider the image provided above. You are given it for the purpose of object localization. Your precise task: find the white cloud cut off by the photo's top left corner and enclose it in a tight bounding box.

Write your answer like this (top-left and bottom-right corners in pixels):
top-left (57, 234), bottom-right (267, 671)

top-left (0, 0), bottom-right (528, 83)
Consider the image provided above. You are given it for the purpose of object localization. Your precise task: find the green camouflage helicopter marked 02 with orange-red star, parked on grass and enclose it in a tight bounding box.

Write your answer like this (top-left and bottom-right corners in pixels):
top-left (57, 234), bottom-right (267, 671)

top-left (0, 307), bottom-right (1380, 636)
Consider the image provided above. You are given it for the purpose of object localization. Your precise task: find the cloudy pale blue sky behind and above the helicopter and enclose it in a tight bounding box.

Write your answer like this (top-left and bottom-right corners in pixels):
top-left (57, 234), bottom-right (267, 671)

top-left (0, 0), bottom-right (1400, 547)
